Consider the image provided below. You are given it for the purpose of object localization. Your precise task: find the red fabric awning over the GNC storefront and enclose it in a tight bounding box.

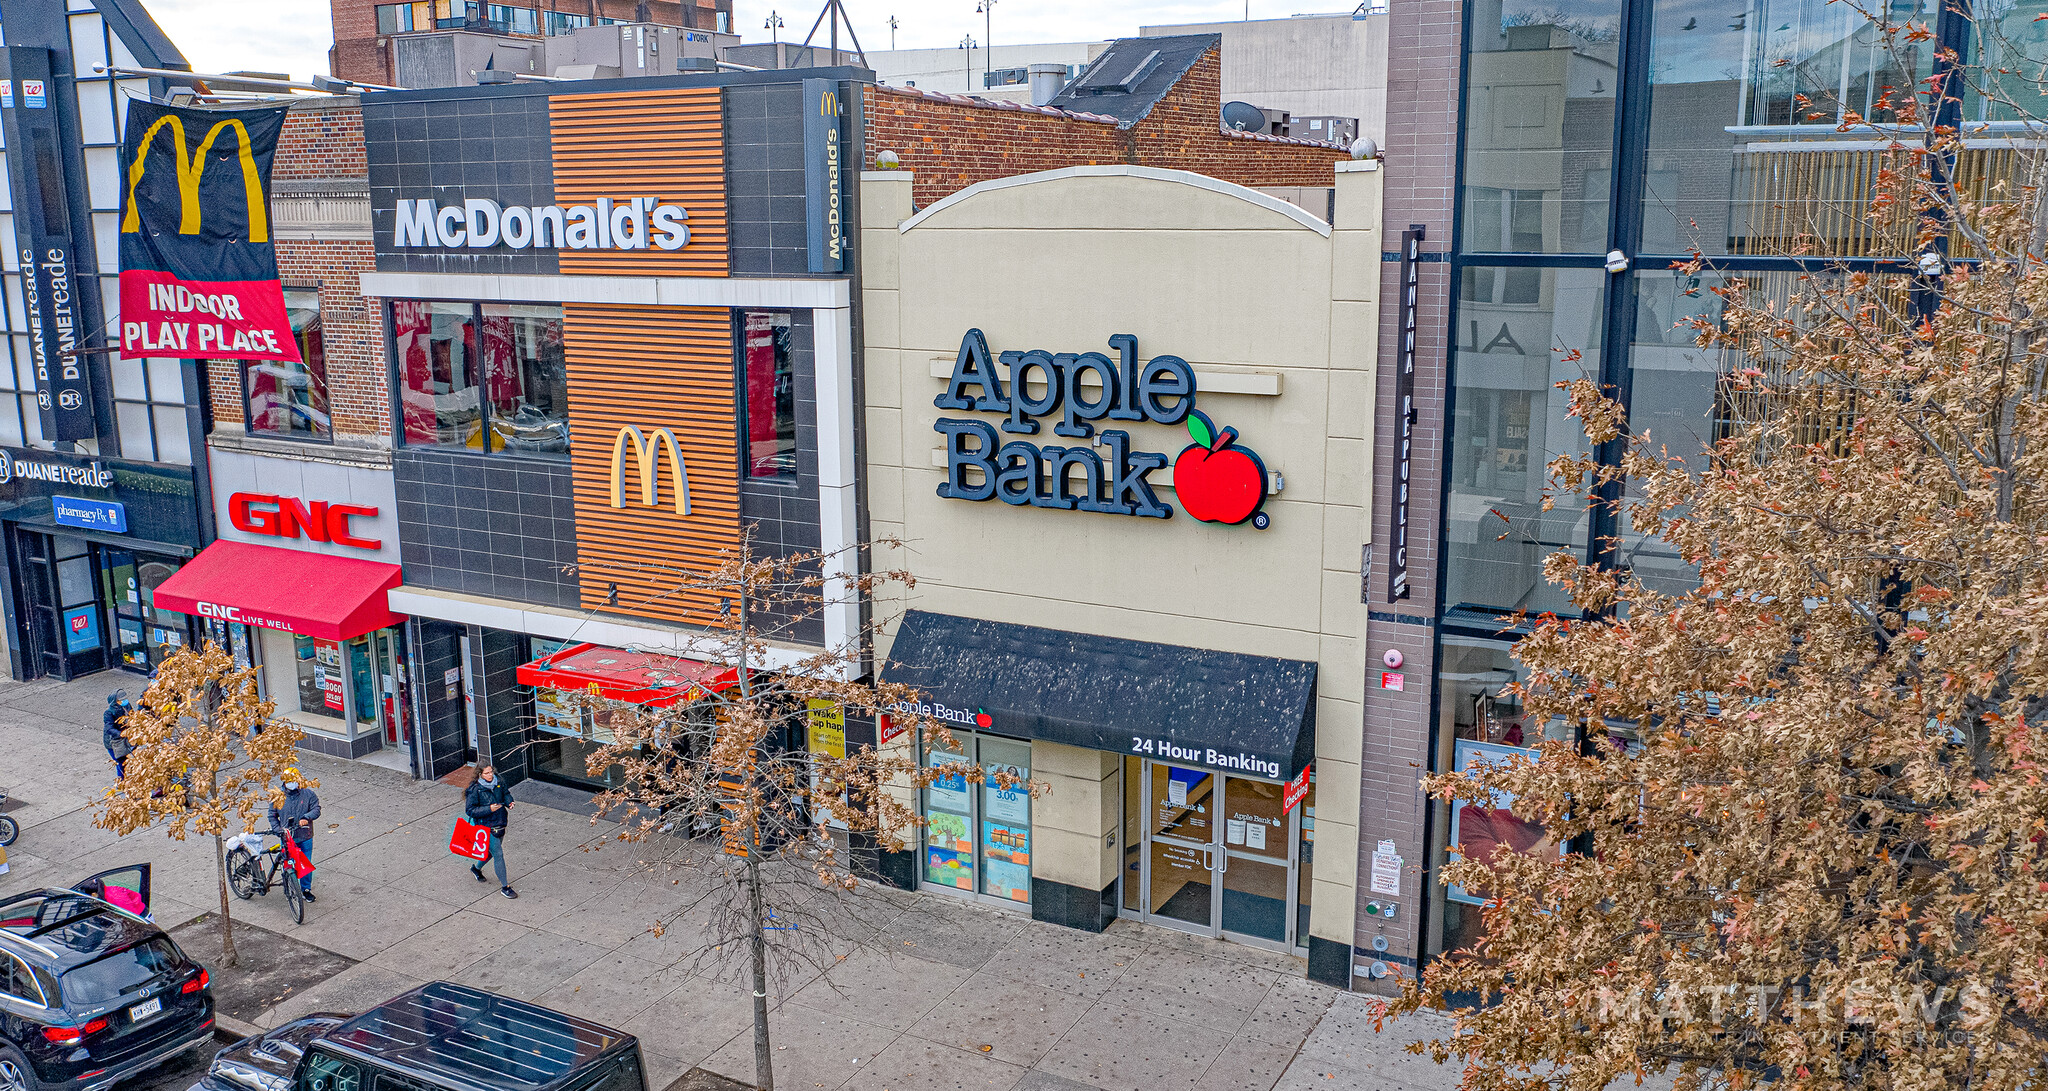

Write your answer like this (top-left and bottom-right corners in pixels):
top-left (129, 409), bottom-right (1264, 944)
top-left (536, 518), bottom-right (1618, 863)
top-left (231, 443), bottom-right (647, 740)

top-left (156, 542), bottom-right (406, 641)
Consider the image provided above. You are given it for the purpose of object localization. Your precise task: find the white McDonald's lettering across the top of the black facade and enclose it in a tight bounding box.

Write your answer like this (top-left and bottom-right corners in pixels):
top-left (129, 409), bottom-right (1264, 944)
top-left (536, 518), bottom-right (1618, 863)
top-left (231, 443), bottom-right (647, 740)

top-left (391, 197), bottom-right (690, 250)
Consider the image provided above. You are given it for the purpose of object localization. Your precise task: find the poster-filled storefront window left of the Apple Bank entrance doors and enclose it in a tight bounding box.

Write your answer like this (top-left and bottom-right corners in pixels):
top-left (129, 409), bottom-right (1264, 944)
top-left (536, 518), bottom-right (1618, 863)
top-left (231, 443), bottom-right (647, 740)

top-left (924, 733), bottom-right (1030, 903)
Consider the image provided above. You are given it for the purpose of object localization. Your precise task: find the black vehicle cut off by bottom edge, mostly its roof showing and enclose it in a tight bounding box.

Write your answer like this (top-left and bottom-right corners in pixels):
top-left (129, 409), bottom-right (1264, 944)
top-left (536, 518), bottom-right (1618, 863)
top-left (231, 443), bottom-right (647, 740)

top-left (190, 980), bottom-right (647, 1091)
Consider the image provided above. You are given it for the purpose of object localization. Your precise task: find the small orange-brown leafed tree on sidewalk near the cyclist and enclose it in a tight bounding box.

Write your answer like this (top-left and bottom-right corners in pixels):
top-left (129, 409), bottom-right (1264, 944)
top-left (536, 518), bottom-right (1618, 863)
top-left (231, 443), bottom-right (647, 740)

top-left (92, 641), bottom-right (313, 966)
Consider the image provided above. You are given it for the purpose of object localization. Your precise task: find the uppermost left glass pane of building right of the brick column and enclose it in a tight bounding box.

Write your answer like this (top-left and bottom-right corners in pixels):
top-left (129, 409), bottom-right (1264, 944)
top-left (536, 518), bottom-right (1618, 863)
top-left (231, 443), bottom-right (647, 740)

top-left (1462, 0), bottom-right (1622, 254)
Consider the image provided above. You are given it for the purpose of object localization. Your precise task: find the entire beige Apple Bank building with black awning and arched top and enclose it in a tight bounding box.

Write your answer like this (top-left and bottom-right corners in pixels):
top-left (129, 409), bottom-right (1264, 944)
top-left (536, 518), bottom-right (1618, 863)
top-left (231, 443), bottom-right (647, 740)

top-left (858, 162), bottom-right (1384, 987)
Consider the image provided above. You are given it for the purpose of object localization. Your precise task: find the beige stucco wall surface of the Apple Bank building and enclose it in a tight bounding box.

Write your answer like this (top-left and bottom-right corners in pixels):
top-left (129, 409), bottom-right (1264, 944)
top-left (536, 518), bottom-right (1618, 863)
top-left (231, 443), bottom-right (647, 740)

top-left (860, 162), bottom-right (1382, 974)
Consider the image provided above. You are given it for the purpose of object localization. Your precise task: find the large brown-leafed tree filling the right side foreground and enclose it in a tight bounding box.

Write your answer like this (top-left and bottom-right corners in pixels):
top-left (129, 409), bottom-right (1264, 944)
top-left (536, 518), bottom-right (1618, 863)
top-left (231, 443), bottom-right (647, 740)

top-left (1389, 10), bottom-right (2048, 1091)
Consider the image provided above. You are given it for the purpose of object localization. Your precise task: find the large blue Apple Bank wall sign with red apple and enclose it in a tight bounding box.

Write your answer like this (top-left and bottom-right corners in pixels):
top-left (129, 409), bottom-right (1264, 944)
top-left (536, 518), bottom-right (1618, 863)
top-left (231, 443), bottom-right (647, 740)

top-left (934, 330), bottom-right (1270, 528)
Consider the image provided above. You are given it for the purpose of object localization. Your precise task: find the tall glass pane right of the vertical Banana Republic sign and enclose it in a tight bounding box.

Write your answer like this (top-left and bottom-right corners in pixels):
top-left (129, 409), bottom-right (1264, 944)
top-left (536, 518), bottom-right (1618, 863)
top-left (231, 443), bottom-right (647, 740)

top-left (1444, 266), bottom-right (1606, 612)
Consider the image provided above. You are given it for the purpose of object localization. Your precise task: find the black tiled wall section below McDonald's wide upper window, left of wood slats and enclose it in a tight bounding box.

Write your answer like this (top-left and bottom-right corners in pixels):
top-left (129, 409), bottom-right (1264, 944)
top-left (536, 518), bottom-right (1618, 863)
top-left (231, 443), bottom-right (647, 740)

top-left (391, 446), bottom-right (580, 608)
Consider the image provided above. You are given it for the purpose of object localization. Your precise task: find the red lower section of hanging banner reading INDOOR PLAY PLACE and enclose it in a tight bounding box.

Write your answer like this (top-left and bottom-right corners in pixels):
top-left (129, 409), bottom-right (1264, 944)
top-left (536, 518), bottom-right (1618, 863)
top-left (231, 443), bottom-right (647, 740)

top-left (121, 268), bottom-right (299, 362)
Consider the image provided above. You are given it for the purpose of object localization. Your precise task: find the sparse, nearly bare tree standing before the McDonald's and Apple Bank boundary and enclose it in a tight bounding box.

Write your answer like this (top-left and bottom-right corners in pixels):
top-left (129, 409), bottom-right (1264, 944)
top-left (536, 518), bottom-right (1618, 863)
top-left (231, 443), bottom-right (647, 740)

top-left (569, 542), bottom-right (1044, 1091)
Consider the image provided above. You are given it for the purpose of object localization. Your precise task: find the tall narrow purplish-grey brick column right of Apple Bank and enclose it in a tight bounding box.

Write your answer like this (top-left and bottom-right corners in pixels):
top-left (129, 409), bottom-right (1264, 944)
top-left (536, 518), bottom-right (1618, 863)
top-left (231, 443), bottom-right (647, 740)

top-left (1356, 0), bottom-right (1462, 991)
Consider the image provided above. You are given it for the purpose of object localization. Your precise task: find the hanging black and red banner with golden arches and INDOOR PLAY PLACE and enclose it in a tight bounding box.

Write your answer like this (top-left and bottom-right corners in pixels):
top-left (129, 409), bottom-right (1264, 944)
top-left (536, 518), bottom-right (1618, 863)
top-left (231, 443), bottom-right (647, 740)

top-left (121, 100), bottom-right (299, 360)
